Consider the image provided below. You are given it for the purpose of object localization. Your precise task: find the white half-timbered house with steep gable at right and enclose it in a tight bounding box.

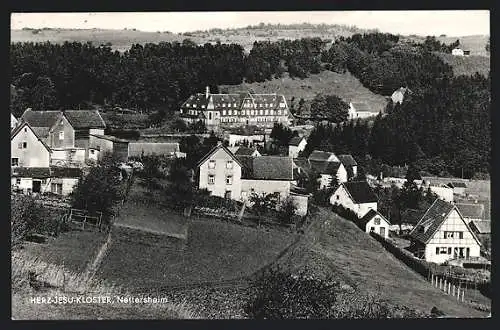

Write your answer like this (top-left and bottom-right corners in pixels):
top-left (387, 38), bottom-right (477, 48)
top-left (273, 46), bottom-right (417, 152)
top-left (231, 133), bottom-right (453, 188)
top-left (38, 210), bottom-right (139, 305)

top-left (410, 198), bottom-right (481, 264)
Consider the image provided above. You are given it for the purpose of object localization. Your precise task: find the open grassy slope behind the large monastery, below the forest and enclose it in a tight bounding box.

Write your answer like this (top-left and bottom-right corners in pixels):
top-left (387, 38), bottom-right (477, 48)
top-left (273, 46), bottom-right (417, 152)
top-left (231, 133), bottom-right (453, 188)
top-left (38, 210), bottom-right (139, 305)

top-left (220, 71), bottom-right (387, 111)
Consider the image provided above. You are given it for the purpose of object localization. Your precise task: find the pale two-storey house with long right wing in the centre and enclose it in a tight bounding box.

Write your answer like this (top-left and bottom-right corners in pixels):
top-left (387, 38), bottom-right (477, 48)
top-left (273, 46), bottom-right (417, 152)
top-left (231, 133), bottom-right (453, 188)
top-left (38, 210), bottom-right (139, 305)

top-left (197, 143), bottom-right (303, 211)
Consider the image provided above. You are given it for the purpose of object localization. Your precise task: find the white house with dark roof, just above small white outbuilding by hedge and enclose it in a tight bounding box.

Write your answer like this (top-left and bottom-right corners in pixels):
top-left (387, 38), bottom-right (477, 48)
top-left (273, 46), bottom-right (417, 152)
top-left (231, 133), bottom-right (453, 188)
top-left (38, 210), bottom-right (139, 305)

top-left (330, 181), bottom-right (378, 218)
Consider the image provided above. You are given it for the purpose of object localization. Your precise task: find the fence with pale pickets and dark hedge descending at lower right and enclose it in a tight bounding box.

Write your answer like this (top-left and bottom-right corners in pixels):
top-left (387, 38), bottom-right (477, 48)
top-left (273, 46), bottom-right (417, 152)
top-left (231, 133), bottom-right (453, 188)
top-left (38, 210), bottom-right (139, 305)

top-left (370, 233), bottom-right (491, 311)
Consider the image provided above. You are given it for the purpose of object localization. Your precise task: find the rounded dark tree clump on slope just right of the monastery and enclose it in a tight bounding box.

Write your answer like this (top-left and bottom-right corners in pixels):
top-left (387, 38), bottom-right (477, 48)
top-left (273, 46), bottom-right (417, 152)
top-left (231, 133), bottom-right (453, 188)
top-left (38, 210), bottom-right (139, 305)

top-left (311, 94), bottom-right (349, 123)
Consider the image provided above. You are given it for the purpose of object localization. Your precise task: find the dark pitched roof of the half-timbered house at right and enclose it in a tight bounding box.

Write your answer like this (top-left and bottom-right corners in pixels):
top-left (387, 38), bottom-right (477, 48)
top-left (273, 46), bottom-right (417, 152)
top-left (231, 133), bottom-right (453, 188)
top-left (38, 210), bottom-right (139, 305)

top-left (410, 198), bottom-right (481, 245)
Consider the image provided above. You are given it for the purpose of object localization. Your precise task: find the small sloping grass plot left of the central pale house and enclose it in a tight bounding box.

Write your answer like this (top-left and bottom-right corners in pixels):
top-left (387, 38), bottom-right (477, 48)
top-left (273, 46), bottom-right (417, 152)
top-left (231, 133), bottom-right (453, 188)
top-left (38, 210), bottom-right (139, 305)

top-left (115, 179), bottom-right (187, 237)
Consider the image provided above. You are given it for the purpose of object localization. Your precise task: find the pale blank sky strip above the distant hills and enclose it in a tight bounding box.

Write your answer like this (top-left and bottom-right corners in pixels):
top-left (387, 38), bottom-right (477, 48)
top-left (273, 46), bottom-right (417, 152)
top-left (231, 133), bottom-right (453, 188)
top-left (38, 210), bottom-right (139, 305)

top-left (11, 10), bottom-right (490, 36)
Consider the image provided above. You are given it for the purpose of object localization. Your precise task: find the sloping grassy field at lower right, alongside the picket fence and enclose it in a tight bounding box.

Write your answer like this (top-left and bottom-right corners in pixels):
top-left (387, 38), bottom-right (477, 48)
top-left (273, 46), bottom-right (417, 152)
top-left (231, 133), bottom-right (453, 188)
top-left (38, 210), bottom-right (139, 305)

top-left (279, 209), bottom-right (486, 317)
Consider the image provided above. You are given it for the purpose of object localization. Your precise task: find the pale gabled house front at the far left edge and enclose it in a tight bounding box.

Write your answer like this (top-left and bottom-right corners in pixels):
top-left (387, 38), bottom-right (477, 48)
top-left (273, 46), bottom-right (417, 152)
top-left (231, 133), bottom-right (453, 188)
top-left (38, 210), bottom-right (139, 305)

top-left (10, 122), bottom-right (51, 167)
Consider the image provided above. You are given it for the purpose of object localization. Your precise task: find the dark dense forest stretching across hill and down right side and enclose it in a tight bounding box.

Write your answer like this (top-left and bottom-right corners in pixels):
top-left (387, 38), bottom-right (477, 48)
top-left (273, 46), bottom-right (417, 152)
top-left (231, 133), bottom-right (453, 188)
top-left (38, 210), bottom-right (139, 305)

top-left (10, 33), bottom-right (491, 176)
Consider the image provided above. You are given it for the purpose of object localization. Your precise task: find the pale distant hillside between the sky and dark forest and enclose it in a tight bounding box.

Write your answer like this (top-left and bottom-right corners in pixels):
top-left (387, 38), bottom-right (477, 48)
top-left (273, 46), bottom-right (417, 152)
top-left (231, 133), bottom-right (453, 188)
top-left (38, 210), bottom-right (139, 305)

top-left (10, 24), bottom-right (369, 52)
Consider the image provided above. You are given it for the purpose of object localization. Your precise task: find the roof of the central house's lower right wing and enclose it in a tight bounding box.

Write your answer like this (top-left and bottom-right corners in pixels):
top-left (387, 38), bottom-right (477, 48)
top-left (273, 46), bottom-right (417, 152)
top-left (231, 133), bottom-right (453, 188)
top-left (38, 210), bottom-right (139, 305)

top-left (251, 156), bottom-right (293, 180)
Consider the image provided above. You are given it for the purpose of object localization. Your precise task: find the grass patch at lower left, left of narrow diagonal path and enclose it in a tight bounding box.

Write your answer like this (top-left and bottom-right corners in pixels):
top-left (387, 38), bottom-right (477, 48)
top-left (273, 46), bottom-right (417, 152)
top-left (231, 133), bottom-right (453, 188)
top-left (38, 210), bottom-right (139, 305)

top-left (19, 231), bottom-right (106, 272)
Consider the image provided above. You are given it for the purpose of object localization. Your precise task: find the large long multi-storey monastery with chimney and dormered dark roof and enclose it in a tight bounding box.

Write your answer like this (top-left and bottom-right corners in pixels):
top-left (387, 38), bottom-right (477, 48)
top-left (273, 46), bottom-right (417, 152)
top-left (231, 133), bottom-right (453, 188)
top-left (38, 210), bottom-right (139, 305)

top-left (179, 86), bottom-right (290, 130)
